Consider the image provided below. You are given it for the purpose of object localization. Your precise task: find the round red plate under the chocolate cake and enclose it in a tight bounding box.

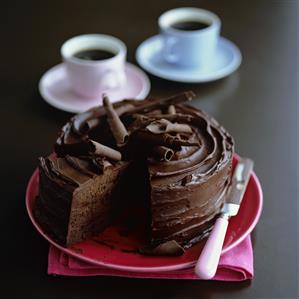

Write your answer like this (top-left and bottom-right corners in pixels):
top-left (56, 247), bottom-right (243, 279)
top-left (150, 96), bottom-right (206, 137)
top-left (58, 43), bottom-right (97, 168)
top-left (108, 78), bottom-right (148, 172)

top-left (26, 156), bottom-right (263, 272)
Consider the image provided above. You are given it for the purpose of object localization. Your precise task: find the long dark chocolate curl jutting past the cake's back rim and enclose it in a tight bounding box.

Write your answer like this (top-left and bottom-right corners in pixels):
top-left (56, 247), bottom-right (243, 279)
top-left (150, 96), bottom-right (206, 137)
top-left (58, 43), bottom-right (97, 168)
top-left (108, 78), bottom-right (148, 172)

top-left (123, 91), bottom-right (195, 114)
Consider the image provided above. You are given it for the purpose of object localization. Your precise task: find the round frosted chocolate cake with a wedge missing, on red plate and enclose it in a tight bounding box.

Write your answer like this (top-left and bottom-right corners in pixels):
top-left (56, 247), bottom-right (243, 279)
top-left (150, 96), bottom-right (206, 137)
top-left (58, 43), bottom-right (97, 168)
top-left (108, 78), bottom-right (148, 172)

top-left (34, 92), bottom-right (234, 252)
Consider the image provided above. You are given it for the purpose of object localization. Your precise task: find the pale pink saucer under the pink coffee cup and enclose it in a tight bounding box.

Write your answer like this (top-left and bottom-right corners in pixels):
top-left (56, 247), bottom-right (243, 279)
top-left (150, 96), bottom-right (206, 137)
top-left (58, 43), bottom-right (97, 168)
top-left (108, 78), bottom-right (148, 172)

top-left (39, 63), bottom-right (150, 113)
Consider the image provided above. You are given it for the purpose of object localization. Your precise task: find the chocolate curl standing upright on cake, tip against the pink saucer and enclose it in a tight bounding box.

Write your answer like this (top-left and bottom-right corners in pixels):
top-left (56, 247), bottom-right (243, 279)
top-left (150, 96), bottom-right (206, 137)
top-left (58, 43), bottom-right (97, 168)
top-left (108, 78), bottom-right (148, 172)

top-left (103, 94), bottom-right (129, 146)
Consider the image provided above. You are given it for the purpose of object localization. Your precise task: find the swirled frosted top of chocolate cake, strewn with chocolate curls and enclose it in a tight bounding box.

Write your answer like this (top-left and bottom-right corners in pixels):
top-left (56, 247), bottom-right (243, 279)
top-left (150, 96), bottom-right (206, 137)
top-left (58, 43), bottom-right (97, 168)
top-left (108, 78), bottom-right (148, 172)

top-left (55, 91), bottom-right (234, 185)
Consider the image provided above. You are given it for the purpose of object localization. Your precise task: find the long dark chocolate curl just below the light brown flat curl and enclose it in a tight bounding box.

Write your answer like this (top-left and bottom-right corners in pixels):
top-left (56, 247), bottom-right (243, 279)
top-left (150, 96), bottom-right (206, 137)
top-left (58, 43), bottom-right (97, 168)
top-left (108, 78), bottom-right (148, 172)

top-left (136, 131), bottom-right (199, 150)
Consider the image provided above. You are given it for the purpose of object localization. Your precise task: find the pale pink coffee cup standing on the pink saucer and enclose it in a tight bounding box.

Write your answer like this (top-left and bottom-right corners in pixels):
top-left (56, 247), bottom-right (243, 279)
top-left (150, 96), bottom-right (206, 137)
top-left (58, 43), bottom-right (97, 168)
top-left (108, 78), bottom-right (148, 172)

top-left (60, 34), bottom-right (127, 97)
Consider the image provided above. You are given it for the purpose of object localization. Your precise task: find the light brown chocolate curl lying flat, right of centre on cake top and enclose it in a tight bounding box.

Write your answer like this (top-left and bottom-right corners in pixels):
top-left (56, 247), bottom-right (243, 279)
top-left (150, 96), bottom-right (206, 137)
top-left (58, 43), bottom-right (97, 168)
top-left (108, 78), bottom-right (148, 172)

top-left (146, 119), bottom-right (192, 134)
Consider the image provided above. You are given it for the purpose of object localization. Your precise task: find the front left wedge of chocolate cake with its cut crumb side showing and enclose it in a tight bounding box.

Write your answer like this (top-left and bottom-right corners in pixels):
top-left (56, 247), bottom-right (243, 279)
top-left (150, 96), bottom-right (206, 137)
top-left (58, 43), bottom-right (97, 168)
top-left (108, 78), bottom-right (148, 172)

top-left (35, 156), bottom-right (128, 246)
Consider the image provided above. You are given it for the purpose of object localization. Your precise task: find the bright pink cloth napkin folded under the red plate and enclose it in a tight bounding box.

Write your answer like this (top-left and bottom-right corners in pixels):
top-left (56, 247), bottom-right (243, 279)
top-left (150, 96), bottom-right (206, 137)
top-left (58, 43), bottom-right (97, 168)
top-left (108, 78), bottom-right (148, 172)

top-left (48, 236), bottom-right (253, 281)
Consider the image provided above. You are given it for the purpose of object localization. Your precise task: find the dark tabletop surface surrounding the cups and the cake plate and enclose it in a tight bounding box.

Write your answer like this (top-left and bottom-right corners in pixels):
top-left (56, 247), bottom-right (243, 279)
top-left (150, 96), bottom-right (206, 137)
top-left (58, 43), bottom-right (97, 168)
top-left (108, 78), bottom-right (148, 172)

top-left (0, 0), bottom-right (299, 298)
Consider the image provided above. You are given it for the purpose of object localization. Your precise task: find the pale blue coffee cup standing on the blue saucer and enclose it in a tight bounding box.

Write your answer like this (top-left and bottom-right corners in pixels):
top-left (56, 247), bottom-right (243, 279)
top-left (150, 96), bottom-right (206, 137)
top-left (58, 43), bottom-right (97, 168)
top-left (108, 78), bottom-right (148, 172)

top-left (158, 7), bottom-right (221, 68)
